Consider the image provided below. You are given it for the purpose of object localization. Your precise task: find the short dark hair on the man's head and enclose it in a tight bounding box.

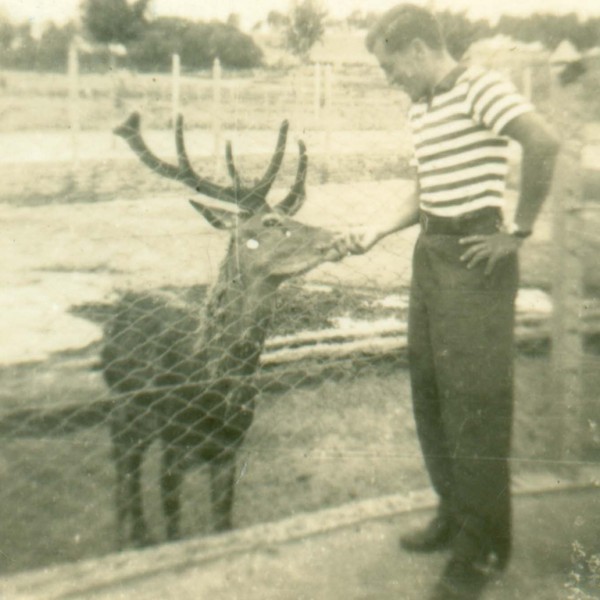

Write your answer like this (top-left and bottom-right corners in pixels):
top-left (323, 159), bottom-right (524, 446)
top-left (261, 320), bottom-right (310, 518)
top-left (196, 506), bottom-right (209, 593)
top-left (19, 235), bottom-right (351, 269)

top-left (365, 4), bottom-right (446, 52)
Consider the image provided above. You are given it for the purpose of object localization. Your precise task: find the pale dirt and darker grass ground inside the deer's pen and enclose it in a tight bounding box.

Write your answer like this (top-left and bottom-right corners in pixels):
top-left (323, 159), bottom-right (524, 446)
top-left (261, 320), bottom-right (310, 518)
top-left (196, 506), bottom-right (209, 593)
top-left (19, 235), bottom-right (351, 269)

top-left (0, 170), bottom-right (597, 572)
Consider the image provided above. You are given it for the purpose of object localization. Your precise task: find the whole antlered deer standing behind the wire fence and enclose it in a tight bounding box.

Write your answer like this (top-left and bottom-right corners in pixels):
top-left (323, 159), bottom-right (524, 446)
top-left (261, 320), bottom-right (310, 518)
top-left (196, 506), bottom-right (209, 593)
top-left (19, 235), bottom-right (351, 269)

top-left (101, 112), bottom-right (338, 548)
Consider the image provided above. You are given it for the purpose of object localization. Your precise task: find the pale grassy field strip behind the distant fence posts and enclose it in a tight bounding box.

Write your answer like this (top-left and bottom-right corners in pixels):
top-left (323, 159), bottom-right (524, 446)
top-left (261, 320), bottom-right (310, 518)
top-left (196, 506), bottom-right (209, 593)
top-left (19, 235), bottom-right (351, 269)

top-left (0, 67), bottom-right (406, 132)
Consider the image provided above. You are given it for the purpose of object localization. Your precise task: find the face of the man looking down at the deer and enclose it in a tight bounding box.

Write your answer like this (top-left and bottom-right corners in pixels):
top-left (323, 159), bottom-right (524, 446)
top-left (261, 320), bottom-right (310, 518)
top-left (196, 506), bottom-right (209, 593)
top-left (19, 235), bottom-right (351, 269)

top-left (373, 39), bottom-right (429, 102)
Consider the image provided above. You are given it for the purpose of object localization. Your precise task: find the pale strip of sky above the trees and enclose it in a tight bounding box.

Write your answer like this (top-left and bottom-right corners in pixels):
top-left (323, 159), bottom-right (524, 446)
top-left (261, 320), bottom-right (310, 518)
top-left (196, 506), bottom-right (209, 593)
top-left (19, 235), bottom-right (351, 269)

top-left (0, 0), bottom-right (600, 28)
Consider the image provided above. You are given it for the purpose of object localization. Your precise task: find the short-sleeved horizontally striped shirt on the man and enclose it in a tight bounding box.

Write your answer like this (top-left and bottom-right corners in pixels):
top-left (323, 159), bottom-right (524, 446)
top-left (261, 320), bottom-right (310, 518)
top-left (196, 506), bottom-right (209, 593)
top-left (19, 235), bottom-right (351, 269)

top-left (409, 66), bottom-right (533, 217)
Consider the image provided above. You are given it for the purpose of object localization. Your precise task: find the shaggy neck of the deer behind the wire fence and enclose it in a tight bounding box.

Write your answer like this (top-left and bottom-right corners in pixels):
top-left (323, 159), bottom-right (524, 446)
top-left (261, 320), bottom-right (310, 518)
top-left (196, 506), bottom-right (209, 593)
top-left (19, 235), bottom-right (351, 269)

top-left (197, 254), bottom-right (275, 378)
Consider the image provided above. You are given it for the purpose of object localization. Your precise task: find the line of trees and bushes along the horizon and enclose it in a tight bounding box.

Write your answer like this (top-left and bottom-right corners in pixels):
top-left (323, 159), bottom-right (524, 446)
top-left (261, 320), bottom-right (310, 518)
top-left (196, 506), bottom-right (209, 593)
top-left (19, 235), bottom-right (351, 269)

top-left (0, 0), bottom-right (600, 71)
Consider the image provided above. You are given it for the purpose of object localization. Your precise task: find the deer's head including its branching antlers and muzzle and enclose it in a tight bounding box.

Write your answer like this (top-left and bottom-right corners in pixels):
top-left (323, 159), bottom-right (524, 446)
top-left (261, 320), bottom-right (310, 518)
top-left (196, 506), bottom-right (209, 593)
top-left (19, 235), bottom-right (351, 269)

top-left (114, 113), bottom-right (337, 283)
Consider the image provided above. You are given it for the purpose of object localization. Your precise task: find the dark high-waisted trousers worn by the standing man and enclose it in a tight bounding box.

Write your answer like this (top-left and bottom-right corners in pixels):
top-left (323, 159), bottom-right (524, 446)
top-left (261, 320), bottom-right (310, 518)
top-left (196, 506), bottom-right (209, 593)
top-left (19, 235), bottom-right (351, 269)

top-left (408, 212), bottom-right (518, 565)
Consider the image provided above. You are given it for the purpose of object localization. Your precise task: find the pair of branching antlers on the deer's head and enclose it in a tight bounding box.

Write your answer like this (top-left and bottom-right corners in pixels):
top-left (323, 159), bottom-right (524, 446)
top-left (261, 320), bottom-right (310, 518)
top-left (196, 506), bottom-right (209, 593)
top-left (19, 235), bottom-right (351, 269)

top-left (114, 112), bottom-right (308, 214)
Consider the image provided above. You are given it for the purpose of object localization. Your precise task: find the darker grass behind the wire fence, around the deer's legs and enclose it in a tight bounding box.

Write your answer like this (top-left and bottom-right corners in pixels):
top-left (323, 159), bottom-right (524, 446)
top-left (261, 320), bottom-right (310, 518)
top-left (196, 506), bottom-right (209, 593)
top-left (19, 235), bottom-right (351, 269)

top-left (0, 357), bottom-right (600, 572)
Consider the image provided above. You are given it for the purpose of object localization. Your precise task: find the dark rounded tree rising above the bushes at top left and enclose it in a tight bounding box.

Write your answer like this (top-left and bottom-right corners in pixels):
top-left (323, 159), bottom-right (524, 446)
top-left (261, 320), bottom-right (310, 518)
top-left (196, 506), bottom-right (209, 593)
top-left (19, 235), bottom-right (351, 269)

top-left (83, 0), bottom-right (150, 46)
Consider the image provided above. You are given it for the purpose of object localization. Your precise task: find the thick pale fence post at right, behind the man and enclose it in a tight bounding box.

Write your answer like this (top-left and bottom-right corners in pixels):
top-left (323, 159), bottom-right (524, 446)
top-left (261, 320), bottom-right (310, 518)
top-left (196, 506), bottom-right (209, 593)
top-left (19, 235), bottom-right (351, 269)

top-left (551, 140), bottom-right (584, 464)
